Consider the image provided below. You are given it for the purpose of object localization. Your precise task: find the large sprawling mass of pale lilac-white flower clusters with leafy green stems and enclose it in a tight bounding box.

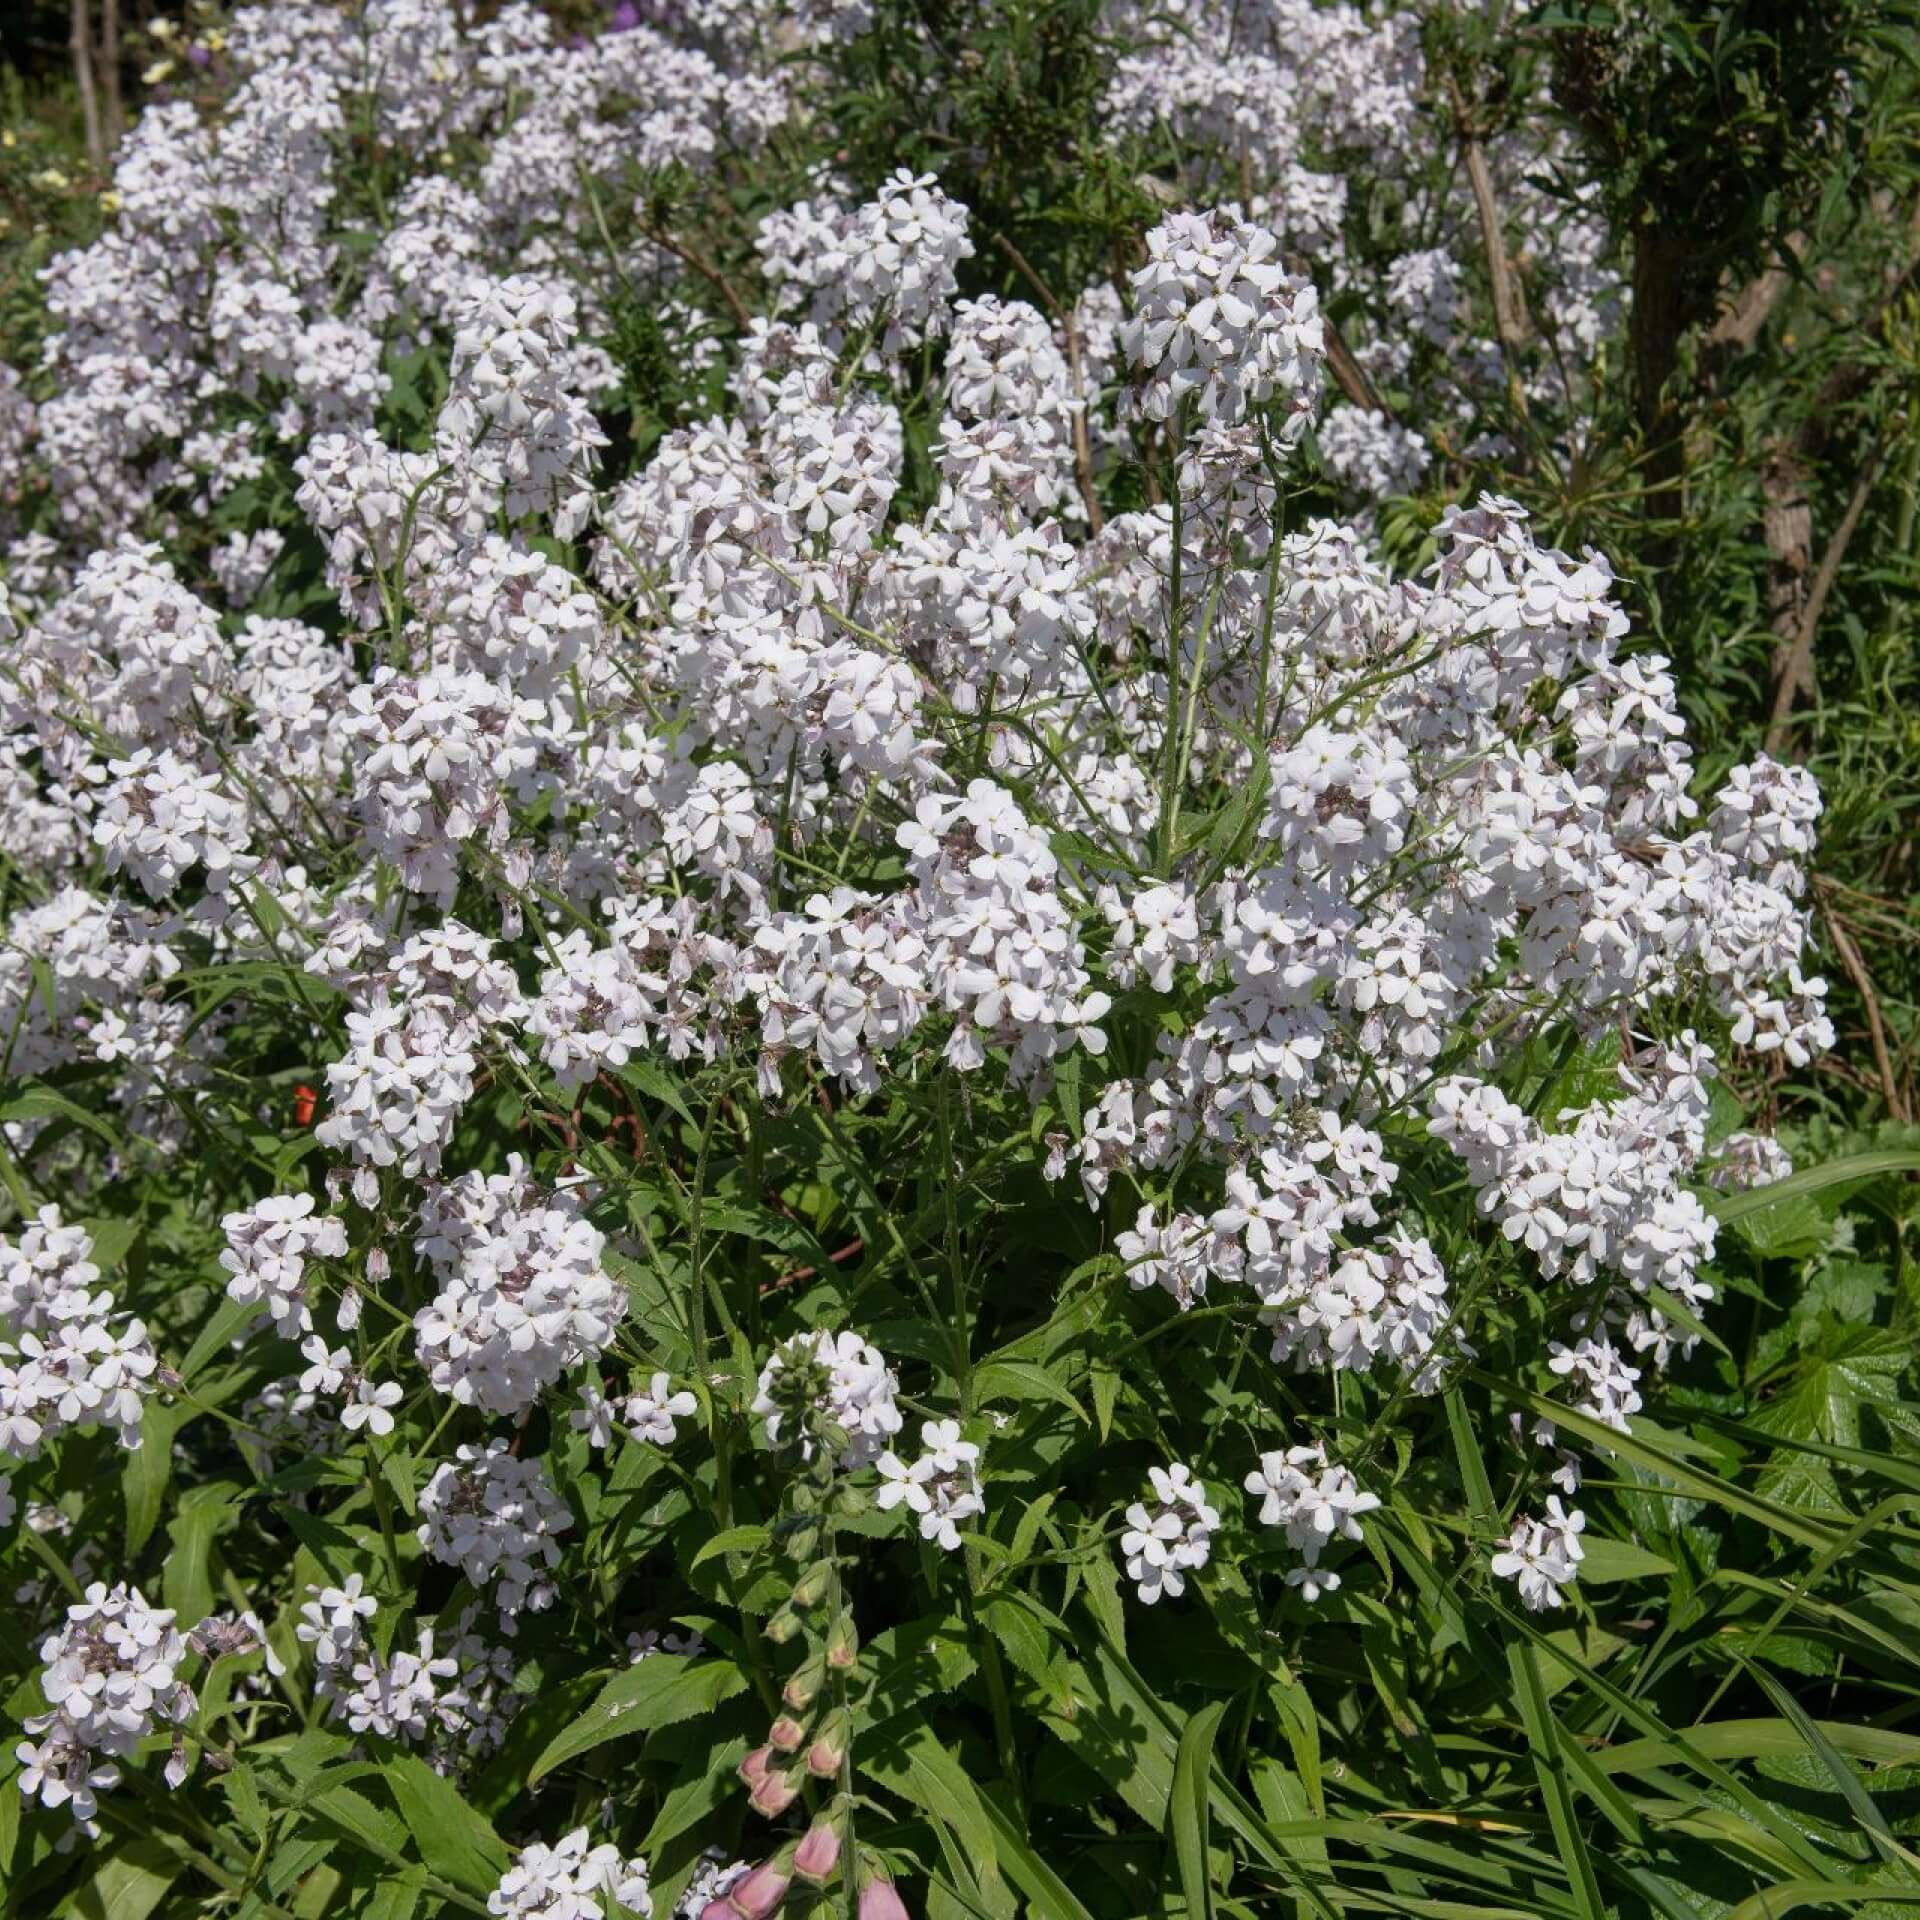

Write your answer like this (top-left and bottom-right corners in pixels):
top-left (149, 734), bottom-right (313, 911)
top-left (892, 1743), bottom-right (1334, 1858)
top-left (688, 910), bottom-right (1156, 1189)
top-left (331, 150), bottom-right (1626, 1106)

top-left (0, 0), bottom-right (1834, 1896)
